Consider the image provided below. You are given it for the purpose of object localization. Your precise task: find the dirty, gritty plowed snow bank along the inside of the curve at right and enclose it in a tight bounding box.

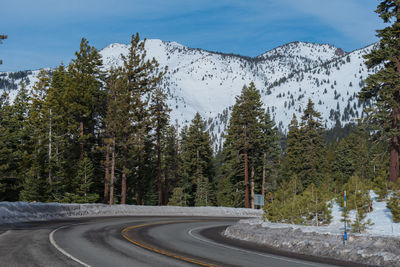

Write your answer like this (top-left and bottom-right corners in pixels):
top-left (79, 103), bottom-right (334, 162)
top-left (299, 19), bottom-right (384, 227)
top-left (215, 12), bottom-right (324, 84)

top-left (224, 220), bottom-right (400, 266)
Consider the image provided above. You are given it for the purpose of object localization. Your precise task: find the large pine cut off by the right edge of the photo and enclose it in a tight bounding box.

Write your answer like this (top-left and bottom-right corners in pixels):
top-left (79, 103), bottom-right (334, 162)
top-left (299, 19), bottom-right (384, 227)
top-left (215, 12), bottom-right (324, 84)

top-left (360, 0), bottom-right (400, 182)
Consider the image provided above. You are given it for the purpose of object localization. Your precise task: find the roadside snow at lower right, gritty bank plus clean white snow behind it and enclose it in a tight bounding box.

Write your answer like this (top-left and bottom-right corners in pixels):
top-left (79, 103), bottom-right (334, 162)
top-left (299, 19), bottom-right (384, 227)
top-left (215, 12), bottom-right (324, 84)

top-left (224, 194), bottom-right (400, 266)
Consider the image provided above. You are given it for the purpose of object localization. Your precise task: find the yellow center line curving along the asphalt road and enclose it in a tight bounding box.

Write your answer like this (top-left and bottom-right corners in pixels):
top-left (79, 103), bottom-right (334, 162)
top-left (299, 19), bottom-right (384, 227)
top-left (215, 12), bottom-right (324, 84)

top-left (121, 221), bottom-right (215, 267)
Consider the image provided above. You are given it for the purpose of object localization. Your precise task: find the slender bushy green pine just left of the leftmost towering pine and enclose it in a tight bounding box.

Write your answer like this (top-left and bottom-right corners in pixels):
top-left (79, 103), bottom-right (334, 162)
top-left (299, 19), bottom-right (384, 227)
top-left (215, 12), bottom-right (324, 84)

top-left (46, 65), bottom-right (72, 200)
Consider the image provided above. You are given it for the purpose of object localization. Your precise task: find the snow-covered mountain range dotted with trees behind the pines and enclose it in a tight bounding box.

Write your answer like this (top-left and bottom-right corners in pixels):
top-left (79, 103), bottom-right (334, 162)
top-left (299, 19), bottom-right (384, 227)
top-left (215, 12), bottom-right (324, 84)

top-left (0, 39), bottom-right (376, 147)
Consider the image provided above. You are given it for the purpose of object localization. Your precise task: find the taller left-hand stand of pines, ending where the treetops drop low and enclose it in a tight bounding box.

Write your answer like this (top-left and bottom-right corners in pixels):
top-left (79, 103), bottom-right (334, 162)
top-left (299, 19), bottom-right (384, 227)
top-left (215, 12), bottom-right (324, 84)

top-left (0, 34), bottom-right (178, 205)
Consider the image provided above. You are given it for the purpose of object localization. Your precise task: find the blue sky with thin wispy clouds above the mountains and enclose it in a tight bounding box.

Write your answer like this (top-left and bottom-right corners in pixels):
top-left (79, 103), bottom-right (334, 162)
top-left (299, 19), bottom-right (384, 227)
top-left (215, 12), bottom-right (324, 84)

top-left (0, 0), bottom-right (384, 71)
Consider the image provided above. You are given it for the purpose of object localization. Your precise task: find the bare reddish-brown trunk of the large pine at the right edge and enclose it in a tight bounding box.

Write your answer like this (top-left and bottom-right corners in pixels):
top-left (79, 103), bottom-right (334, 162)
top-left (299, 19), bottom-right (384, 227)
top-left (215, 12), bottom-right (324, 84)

top-left (389, 107), bottom-right (400, 183)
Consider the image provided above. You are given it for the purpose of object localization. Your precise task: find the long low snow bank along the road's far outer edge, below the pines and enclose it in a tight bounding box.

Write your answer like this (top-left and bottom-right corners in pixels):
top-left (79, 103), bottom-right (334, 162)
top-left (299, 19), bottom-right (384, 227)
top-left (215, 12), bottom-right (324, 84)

top-left (0, 202), bottom-right (262, 224)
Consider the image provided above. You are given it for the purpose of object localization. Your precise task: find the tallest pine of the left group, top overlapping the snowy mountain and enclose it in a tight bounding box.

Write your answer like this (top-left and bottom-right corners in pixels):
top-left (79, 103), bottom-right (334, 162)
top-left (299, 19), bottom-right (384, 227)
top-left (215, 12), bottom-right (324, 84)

top-left (122, 34), bottom-right (166, 205)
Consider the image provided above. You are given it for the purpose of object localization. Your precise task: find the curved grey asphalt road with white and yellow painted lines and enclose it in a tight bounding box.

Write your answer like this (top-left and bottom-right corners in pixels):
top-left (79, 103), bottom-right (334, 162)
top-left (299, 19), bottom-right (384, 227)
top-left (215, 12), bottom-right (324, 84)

top-left (0, 216), bottom-right (350, 267)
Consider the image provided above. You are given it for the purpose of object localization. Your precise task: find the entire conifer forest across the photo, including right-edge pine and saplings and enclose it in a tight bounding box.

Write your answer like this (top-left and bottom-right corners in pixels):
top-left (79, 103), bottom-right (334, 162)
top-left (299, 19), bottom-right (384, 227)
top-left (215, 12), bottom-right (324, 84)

top-left (0, 0), bottom-right (400, 232)
